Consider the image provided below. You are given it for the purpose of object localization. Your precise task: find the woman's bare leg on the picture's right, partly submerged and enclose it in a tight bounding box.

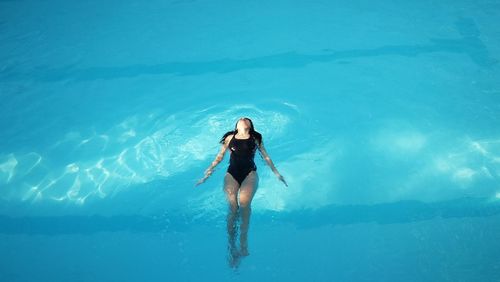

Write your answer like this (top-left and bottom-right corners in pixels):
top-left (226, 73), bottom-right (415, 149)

top-left (239, 171), bottom-right (259, 256)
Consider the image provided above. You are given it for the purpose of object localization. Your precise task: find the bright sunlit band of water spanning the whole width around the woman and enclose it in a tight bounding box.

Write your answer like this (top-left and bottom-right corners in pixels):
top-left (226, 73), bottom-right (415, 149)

top-left (0, 103), bottom-right (500, 215)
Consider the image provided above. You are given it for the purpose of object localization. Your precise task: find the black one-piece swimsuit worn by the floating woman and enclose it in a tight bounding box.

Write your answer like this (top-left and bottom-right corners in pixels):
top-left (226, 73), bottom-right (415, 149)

top-left (227, 135), bottom-right (257, 185)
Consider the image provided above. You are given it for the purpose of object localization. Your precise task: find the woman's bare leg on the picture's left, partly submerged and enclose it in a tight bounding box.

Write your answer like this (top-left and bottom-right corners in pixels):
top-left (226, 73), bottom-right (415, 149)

top-left (224, 173), bottom-right (239, 267)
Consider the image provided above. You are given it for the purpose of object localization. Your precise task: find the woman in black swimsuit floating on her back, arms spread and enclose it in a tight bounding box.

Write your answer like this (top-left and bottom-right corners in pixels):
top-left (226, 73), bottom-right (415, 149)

top-left (196, 118), bottom-right (288, 267)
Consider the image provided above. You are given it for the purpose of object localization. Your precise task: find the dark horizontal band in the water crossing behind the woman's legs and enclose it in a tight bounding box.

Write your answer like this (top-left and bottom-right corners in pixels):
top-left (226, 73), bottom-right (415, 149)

top-left (0, 197), bottom-right (500, 235)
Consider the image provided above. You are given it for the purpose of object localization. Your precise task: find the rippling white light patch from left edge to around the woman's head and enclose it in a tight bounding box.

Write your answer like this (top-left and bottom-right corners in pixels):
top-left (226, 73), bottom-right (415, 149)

top-left (0, 102), bottom-right (296, 208)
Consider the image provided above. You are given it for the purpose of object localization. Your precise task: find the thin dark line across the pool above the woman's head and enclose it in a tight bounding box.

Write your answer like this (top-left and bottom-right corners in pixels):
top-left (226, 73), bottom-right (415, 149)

top-left (0, 18), bottom-right (498, 81)
